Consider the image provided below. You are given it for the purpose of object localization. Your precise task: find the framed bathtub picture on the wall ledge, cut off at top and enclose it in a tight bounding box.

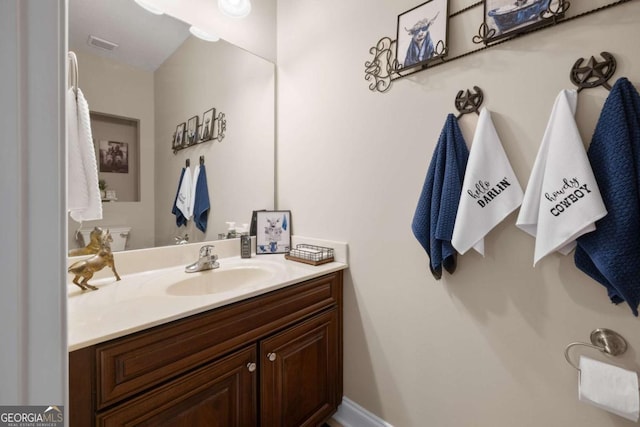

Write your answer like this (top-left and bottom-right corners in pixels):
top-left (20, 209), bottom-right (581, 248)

top-left (484, 0), bottom-right (558, 42)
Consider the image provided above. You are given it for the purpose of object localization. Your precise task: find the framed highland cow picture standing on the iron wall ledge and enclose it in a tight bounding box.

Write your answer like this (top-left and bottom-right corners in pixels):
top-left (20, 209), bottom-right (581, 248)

top-left (396, 0), bottom-right (449, 70)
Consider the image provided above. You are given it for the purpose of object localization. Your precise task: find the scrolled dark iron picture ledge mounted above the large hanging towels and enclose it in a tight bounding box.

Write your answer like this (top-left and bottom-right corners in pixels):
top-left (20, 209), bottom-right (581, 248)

top-left (364, 0), bottom-right (631, 93)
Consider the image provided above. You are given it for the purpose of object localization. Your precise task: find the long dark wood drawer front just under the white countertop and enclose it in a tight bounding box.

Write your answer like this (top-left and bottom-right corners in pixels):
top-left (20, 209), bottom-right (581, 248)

top-left (95, 272), bottom-right (342, 410)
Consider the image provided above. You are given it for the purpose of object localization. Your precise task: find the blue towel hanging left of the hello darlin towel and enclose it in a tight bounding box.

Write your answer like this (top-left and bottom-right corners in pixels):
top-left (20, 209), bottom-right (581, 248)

top-left (411, 114), bottom-right (469, 279)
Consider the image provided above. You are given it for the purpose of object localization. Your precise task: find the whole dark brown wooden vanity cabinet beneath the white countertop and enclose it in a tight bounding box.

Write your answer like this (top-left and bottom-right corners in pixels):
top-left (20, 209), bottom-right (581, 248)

top-left (69, 271), bottom-right (342, 427)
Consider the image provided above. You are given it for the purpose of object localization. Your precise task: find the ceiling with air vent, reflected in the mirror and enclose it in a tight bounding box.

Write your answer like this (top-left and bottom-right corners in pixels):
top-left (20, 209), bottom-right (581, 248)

top-left (69, 0), bottom-right (189, 71)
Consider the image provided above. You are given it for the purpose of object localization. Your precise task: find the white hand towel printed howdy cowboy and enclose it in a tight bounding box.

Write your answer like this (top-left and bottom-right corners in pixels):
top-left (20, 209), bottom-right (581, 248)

top-left (516, 90), bottom-right (607, 266)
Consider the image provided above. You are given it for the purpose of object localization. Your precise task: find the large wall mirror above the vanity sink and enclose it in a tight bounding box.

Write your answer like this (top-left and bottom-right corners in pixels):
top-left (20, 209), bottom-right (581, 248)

top-left (68, 0), bottom-right (275, 249)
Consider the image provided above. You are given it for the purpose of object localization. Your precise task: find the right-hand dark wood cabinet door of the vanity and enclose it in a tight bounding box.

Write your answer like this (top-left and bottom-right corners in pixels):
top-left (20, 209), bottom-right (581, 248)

top-left (260, 308), bottom-right (340, 427)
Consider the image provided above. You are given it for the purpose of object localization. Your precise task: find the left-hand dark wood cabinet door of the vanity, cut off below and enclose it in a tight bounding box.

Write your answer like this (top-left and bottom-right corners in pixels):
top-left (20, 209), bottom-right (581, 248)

top-left (96, 346), bottom-right (258, 427)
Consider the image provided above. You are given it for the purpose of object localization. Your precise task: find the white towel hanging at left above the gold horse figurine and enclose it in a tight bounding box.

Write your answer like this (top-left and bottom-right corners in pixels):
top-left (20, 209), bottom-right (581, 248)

top-left (66, 89), bottom-right (102, 222)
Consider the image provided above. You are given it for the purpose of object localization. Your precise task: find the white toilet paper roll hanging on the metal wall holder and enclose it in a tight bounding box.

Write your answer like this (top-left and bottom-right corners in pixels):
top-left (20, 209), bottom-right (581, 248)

top-left (578, 356), bottom-right (640, 422)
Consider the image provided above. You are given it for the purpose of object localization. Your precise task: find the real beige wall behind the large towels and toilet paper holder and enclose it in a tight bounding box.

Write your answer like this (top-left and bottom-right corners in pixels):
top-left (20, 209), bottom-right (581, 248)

top-left (277, 0), bottom-right (640, 427)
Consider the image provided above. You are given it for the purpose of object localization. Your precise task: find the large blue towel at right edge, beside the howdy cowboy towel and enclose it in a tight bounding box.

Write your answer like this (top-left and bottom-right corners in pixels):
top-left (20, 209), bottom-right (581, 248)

top-left (574, 77), bottom-right (640, 316)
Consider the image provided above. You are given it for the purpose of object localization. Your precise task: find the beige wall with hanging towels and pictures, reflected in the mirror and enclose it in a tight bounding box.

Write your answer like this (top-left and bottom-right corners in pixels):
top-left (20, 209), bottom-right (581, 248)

top-left (155, 37), bottom-right (275, 249)
